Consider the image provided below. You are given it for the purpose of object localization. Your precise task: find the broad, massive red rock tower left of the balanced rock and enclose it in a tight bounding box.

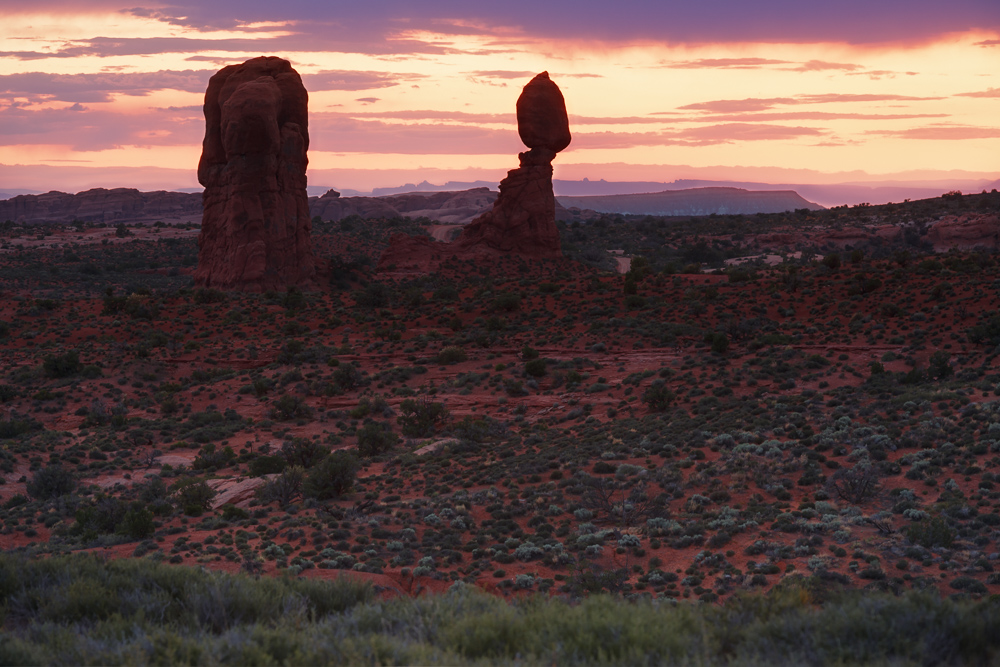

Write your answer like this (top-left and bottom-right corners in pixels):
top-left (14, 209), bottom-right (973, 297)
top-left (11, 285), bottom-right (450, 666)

top-left (194, 56), bottom-right (316, 292)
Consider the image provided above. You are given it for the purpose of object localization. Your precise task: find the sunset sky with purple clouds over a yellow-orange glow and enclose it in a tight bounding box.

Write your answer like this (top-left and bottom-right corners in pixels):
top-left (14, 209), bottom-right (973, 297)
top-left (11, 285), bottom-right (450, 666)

top-left (0, 0), bottom-right (1000, 192)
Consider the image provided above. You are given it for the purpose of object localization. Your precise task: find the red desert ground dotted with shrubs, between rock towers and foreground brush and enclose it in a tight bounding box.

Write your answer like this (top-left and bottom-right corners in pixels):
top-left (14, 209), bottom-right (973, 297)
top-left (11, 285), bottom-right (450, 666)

top-left (0, 192), bottom-right (1000, 602)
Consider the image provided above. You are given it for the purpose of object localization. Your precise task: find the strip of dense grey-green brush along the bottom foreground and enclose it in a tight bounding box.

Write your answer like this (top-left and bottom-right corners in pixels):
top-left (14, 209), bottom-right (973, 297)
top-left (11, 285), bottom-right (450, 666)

top-left (0, 555), bottom-right (1000, 665)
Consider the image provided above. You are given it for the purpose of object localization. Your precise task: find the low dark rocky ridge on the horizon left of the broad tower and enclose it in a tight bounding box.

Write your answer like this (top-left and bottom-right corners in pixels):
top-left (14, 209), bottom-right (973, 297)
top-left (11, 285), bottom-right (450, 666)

top-left (0, 188), bottom-right (201, 224)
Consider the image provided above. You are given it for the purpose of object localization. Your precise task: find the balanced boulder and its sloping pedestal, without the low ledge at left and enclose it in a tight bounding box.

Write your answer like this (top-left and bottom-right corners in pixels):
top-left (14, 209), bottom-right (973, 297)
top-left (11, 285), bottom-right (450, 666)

top-left (455, 72), bottom-right (571, 258)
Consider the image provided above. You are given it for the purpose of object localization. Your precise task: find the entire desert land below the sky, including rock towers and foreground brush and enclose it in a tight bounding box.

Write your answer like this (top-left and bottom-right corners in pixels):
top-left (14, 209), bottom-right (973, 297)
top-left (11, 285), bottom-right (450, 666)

top-left (0, 17), bottom-right (1000, 664)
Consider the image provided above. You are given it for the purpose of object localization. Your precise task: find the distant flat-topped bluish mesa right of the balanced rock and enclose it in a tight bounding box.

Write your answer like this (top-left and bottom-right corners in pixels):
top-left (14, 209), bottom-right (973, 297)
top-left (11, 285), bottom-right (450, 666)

top-left (556, 188), bottom-right (823, 215)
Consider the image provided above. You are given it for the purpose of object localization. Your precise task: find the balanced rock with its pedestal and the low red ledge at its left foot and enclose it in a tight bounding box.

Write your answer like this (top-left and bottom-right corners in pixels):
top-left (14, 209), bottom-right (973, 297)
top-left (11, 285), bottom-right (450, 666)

top-left (378, 72), bottom-right (571, 272)
